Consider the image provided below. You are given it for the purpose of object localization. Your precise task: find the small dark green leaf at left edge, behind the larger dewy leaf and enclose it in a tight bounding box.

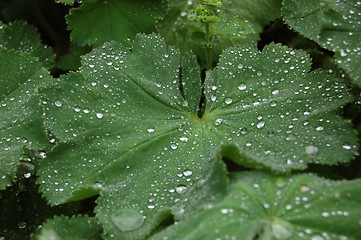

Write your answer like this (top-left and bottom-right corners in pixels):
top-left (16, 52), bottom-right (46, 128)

top-left (0, 21), bottom-right (55, 69)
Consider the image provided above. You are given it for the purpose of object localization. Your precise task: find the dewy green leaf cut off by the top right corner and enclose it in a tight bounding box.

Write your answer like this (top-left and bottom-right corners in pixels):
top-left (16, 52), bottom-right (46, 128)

top-left (282, 0), bottom-right (361, 86)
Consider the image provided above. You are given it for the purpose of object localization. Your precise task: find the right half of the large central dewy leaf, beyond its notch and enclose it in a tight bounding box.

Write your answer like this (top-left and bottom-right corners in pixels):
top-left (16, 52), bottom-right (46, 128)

top-left (203, 44), bottom-right (358, 171)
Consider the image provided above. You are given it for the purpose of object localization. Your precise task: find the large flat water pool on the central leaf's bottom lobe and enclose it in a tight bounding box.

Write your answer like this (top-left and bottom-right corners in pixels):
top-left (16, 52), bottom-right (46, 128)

top-left (111, 208), bottom-right (144, 232)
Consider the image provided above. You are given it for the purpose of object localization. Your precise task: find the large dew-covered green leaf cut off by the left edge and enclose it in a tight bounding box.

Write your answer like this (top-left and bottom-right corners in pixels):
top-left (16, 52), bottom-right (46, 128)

top-left (0, 49), bottom-right (51, 189)
